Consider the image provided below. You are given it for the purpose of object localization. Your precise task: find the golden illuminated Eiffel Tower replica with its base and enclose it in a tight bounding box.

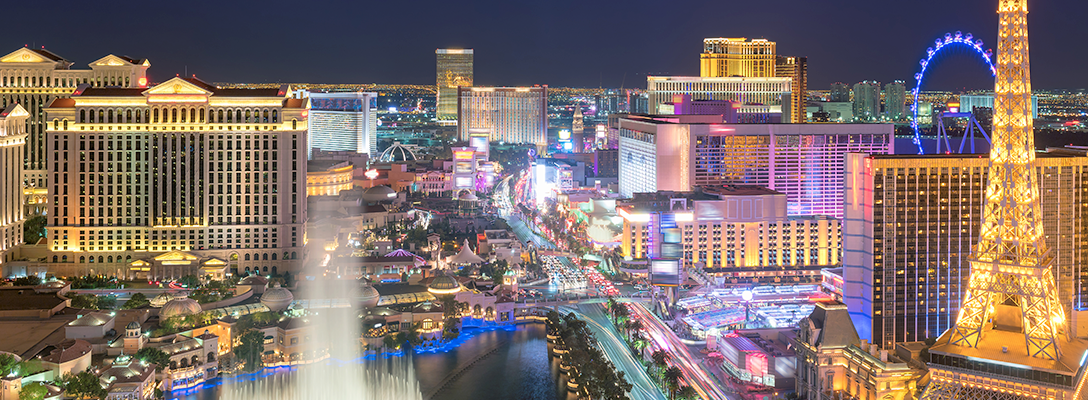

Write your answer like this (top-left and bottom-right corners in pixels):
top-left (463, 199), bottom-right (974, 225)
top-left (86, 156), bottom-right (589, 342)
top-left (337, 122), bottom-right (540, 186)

top-left (923, 0), bottom-right (1088, 400)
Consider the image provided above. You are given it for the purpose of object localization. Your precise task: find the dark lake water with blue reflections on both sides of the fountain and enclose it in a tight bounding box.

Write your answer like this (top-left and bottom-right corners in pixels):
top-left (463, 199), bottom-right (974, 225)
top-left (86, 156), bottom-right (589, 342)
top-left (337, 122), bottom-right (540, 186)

top-left (169, 324), bottom-right (573, 400)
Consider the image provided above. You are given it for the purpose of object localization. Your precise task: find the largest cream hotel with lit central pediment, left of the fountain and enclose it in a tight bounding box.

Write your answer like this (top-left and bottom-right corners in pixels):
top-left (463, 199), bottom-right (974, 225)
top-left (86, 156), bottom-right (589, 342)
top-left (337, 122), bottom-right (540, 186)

top-left (46, 78), bottom-right (308, 277)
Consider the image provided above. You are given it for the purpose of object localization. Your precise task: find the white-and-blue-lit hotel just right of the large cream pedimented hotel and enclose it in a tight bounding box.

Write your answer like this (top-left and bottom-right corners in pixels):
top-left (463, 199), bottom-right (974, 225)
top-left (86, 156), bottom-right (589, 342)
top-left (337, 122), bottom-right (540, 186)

top-left (306, 91), bottom-right (379, 159)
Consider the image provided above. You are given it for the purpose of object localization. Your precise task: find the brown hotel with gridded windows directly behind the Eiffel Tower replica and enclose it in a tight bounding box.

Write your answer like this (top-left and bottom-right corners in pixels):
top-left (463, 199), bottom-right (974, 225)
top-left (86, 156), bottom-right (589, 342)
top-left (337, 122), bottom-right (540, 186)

top-left (842, 149), bottom-right (1088, 347)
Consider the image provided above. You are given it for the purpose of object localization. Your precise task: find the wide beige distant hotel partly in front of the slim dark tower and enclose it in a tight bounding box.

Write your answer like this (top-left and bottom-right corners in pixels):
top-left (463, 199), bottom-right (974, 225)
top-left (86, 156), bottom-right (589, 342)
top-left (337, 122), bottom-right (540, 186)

top-left (457, 86), bottom-right (547, 146)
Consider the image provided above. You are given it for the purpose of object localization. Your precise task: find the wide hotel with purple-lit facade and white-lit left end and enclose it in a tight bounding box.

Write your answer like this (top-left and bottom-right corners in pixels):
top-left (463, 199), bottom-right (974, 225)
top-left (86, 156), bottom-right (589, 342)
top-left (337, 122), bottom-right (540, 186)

top-left (618, 115), bottom-right (893, 218)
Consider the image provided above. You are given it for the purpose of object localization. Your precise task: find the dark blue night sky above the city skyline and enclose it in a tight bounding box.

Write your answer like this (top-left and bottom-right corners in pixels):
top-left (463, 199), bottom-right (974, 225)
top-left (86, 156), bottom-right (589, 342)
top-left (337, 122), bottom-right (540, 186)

top-left (10, 0), bottom-right (1088, 90)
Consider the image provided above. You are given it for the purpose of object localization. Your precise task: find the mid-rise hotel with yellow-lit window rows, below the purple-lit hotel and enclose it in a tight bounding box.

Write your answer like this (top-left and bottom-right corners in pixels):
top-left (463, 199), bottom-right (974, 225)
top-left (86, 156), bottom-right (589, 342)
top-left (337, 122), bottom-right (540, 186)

top-left (616, 185), bottom-right (841, 286)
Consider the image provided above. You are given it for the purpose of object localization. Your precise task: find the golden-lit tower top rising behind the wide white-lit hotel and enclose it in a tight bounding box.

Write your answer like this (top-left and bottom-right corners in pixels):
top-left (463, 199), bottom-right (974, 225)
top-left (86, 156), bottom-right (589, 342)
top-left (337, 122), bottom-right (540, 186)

top-left (700, 38), bottom-right (776, 78)
